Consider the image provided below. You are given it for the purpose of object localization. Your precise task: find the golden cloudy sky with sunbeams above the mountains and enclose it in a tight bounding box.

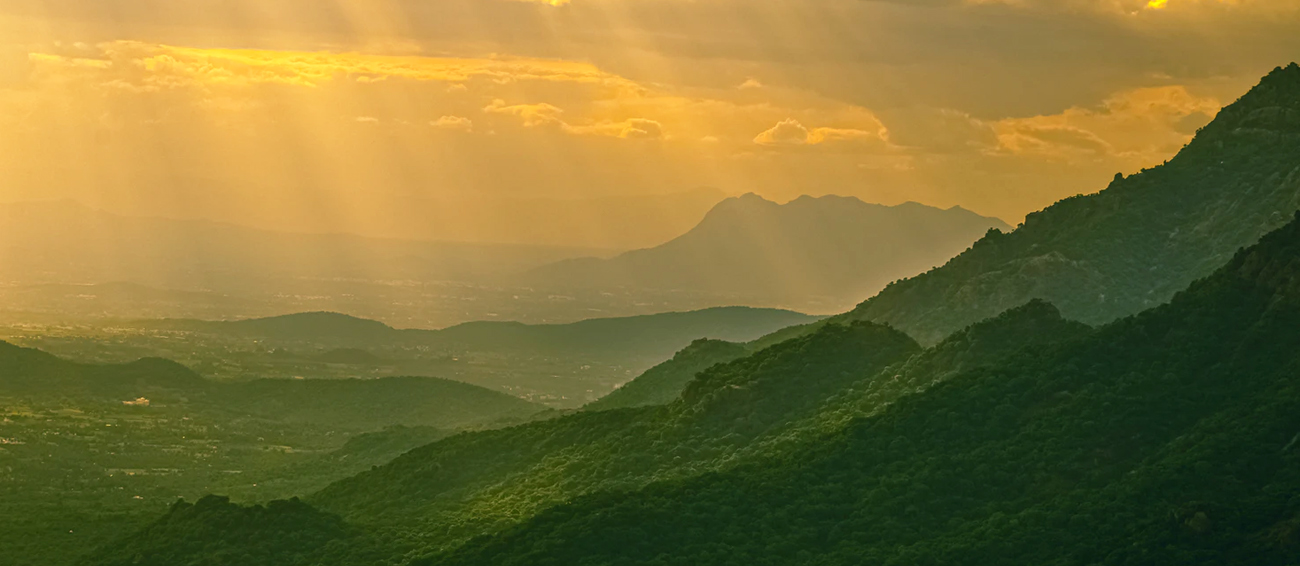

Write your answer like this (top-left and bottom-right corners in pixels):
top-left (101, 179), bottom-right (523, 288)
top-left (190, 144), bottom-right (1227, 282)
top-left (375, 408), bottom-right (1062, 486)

top-left (0, 0), bottom-right (1300, 249)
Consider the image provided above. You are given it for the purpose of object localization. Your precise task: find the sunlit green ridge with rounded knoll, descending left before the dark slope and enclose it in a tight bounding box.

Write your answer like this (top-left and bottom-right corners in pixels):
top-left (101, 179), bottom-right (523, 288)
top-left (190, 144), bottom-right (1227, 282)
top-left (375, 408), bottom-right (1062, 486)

top-left (309, 323), bottom-right (918, 536)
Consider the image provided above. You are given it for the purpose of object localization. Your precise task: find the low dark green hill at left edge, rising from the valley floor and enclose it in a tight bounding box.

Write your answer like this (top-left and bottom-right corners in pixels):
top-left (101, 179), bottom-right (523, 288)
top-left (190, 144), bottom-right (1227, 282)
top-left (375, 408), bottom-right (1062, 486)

top-left (0, 342), bottom-right (543, 431)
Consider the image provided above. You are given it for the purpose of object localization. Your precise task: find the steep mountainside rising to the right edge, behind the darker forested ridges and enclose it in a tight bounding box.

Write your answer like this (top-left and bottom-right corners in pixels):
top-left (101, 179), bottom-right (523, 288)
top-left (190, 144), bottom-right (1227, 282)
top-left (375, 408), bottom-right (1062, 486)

top-left (763, 64), bottom-right (1300, 344)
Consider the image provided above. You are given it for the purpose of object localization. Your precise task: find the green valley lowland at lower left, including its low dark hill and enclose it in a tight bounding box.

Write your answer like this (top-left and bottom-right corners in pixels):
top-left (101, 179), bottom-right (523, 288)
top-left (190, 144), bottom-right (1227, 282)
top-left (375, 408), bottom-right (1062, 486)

top-left (0, 342), bottom-right (542, 566)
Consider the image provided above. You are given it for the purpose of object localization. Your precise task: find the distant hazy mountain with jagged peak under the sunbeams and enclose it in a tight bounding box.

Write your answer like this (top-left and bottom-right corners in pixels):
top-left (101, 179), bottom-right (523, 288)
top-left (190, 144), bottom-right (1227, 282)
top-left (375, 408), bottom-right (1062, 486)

top-left (527, 194), bottom-right (1009, 309)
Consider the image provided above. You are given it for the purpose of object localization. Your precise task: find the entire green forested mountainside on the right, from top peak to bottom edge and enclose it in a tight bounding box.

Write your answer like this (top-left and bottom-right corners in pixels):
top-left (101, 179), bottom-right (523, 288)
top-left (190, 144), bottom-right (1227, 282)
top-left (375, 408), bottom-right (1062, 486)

top-left (55, 65), bottom-right (1300, 566)
